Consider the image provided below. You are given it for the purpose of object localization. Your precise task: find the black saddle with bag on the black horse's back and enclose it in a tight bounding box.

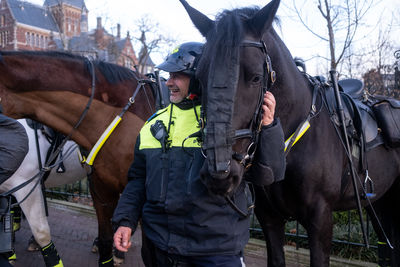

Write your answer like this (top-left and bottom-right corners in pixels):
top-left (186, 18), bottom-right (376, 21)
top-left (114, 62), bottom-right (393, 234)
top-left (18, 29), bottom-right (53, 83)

top-left (324, 79), bottom-right (400, 165)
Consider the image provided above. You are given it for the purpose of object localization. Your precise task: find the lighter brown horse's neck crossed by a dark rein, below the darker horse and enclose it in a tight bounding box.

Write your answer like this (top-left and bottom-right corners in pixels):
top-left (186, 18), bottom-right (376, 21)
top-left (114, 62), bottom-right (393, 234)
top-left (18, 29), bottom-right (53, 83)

top-left (8, 91), bottom-right (114, 148)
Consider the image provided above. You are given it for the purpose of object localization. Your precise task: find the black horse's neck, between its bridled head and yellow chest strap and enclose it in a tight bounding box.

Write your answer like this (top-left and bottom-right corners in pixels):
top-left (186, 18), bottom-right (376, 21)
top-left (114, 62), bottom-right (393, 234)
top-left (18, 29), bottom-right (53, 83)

top-left (264, 30), bottom-right (312, 136)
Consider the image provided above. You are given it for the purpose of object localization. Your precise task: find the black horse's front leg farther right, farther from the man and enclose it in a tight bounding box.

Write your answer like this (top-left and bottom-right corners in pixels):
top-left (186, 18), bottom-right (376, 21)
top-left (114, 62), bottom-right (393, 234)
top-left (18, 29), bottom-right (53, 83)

top-left (299, 202), bottom-right (333, 267)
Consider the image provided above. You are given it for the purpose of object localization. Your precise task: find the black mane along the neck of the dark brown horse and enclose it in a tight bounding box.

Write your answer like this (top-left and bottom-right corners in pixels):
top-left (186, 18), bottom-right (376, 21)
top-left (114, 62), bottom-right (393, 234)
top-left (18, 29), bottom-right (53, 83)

top-left (0, 51), bottom-right (139, 84)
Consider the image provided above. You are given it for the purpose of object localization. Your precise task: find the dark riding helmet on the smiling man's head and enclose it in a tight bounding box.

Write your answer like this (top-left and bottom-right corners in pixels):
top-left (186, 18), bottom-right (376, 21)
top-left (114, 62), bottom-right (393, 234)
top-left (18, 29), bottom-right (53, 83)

top-left (156, 42), bottom-right (203, 76)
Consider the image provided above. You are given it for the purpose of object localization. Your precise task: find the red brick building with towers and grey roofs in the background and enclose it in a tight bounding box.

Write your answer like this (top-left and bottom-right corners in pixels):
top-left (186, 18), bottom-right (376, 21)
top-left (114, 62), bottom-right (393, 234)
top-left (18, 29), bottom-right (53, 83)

top-left (0, 0), bottom-right (147, 72)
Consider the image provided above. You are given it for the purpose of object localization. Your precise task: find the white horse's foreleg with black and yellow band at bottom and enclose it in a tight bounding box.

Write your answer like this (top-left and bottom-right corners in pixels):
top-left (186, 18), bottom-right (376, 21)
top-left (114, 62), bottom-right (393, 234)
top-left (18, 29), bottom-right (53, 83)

top-left (15, 185), bottom-right (63, 267)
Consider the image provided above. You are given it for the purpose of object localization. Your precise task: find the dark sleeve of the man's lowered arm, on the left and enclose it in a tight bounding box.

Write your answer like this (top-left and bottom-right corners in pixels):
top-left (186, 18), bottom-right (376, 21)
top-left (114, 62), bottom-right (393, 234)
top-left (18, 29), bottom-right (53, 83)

top-left (112, 137), bottom-right (146, 232)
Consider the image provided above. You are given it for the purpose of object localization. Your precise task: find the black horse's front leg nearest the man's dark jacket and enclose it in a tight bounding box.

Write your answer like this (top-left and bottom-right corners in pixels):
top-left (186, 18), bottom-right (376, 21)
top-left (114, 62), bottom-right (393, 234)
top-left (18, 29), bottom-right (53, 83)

top-left (254, 186), bottom-right (286, 267)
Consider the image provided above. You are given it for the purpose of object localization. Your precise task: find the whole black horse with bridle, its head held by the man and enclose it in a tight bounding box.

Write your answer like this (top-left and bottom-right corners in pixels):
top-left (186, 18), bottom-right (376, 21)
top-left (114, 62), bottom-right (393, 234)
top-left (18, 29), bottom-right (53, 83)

top-left (181, 0), bottom-right (400, 267)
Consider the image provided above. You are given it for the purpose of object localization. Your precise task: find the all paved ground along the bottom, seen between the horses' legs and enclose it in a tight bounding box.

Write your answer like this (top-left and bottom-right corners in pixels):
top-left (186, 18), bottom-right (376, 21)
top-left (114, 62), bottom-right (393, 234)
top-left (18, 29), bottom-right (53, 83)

top-left (10, 201), bottom-right (377, 267)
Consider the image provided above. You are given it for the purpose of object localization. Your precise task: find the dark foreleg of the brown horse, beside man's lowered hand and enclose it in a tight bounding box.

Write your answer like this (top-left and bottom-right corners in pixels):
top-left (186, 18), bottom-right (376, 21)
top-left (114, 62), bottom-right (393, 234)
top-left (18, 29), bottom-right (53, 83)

top-left (90, 174), bottom-right (119, 267)
